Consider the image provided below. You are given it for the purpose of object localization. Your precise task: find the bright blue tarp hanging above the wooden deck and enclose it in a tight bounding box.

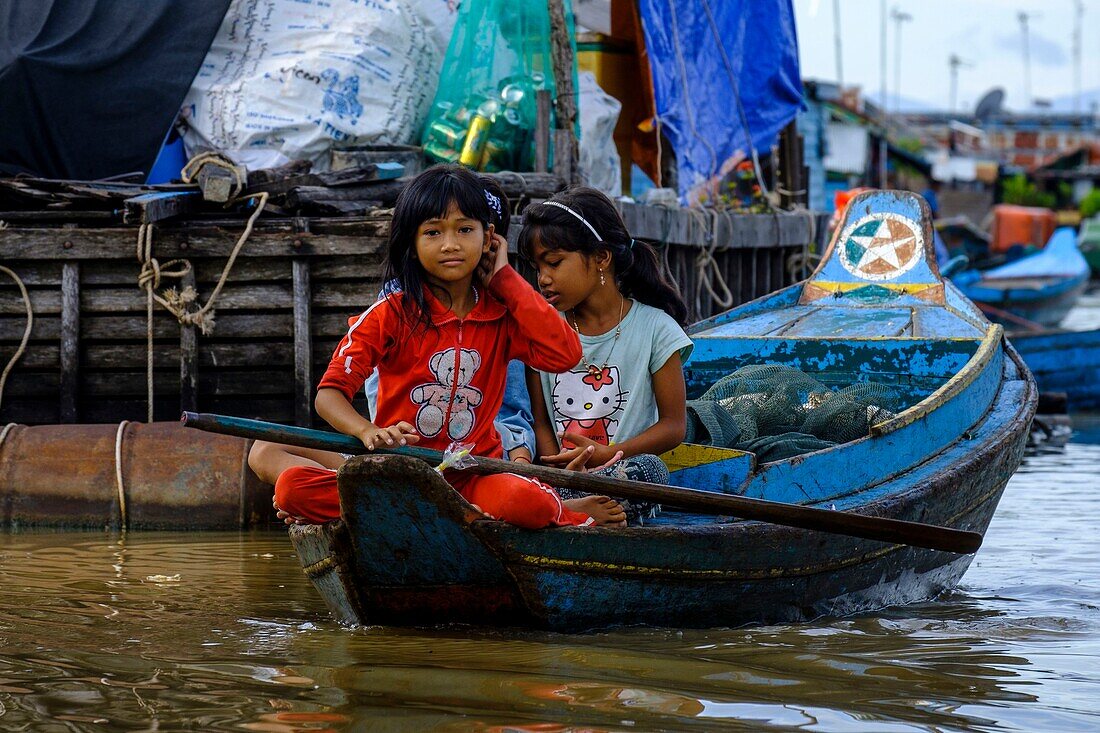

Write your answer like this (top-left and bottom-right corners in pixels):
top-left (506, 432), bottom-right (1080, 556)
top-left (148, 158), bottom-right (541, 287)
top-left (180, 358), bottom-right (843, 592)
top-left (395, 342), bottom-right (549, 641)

top-left (640, 0), bottom-right (802, 203)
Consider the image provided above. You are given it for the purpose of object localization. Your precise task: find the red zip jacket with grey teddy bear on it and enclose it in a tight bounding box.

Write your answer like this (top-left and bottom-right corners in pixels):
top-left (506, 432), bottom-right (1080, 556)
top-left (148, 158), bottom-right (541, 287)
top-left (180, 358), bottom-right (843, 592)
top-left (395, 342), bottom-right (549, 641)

top-left (318, 266), bottom-right (581, 458)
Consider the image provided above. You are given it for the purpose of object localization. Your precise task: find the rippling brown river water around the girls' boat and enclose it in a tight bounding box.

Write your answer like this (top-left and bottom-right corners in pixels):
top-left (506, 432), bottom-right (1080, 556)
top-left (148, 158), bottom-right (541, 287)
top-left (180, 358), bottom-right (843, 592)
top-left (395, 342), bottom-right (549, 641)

top-left (0, 416), bottom-right (1100, 732)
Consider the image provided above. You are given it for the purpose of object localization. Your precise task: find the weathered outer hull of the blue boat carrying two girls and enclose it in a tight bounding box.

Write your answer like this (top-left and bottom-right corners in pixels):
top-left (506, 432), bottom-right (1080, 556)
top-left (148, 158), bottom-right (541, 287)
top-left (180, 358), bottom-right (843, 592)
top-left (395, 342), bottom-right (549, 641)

top-left (292, 343), bottom-right (1035, 631)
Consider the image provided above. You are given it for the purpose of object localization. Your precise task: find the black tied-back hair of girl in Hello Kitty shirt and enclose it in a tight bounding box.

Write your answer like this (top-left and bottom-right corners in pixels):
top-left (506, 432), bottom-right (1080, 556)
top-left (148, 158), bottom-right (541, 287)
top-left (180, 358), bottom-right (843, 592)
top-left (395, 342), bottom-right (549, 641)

top-left (519, 186), bottom-right (688, 326)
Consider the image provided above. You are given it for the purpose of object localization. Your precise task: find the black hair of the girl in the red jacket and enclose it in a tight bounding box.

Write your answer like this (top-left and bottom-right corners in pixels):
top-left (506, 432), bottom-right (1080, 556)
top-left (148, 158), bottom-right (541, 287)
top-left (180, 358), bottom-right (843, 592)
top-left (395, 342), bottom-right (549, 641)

top-left (383, 165), bottom-right (495, 327)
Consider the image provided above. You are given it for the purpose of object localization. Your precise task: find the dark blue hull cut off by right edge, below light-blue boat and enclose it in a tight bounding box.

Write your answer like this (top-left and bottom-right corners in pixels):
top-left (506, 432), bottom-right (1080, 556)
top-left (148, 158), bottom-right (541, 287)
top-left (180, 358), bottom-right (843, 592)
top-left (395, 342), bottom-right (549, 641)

top-left (1011, 329), bottom-right (1100, 409)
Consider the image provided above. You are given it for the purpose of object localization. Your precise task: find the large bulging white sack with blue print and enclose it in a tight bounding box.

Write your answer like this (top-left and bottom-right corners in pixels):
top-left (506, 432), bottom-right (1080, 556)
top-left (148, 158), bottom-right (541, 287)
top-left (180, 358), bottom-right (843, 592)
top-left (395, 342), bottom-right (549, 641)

top-left (180, 0), bottom-right (455, 171)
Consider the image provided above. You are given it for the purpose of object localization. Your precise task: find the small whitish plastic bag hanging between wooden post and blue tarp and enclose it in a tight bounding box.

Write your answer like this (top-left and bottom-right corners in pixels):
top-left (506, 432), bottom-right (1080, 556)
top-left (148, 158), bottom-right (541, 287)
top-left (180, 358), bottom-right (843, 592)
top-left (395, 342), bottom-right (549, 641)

top-left (578, 72), bottom-right (623, 198)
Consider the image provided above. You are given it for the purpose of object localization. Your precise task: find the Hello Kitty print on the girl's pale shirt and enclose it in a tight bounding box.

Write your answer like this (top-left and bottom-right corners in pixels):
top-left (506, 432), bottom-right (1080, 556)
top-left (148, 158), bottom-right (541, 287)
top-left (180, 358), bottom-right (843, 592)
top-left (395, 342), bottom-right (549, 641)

top-left (552, 367), bottom-right (629, 448)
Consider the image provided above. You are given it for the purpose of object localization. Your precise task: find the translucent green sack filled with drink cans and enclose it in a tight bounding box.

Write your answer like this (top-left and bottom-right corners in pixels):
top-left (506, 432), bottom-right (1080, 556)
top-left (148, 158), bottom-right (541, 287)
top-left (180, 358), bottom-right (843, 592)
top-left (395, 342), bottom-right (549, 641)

top-left (421, 0), bottom-right (575, 171)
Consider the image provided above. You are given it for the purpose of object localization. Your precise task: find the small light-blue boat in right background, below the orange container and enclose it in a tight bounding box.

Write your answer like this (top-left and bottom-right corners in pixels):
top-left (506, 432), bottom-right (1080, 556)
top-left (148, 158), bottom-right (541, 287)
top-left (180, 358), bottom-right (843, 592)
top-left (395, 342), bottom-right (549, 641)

top-left (954, 227), bottom-right (1089, 327)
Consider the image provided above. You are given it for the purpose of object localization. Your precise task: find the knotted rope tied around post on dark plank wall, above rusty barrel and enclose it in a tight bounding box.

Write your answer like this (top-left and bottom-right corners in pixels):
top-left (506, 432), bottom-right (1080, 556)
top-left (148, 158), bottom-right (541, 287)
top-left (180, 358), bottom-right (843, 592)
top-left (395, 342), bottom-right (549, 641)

top-left (138, 189), bottom-right (267, 423)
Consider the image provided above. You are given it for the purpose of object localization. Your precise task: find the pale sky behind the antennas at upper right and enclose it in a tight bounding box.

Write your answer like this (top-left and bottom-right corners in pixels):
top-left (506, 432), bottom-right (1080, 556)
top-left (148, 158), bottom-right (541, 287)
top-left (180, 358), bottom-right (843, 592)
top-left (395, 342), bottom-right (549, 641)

top-left (793, 0), bottom-right (1100, 111)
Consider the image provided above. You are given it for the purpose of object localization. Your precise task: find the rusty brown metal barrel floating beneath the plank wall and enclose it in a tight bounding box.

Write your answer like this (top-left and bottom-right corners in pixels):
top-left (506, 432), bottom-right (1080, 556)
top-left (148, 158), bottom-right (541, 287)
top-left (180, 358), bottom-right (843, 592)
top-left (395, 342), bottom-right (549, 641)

top-left (0, 422), bottom-right (275, 530)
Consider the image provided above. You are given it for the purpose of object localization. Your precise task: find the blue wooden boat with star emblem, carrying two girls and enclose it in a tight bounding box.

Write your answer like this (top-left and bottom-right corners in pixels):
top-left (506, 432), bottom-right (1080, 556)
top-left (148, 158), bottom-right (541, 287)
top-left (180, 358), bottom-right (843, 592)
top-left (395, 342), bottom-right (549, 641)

top-left (281, 192), bottom-right (1036, 631)
